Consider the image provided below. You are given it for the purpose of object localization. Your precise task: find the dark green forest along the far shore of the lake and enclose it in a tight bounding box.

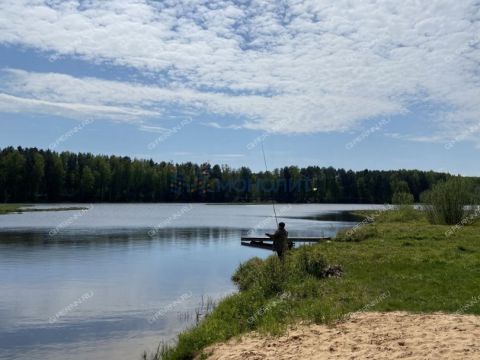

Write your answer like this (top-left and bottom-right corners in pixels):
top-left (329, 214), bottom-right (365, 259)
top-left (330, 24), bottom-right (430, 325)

top-left (0, 147), bottom-right (468, 204)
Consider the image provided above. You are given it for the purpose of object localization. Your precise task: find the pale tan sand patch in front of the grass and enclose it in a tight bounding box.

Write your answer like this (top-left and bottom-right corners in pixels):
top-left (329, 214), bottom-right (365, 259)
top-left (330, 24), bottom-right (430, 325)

top-left (205, 312), bottom-right (480, 360)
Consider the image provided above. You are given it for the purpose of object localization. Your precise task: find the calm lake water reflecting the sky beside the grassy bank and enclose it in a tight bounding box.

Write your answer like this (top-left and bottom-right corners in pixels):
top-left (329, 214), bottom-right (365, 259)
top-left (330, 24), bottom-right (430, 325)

top-left (0, 204), bottom-right (372, 360)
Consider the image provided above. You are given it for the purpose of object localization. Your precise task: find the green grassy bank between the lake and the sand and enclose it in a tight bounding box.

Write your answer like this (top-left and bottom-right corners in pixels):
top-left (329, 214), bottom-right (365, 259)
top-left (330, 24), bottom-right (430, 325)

top-left (157, 208), bottom-right (480, 359)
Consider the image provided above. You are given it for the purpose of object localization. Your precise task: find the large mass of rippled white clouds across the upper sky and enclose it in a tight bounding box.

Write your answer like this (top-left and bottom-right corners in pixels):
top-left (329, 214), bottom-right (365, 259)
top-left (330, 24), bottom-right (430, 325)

top-left (0, 0), bottom-right (480, 136)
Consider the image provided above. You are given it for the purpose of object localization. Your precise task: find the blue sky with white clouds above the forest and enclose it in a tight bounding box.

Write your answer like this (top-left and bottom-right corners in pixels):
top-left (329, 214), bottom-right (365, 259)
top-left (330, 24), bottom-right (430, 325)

top-left (0, 0), bottom-right (480, 176)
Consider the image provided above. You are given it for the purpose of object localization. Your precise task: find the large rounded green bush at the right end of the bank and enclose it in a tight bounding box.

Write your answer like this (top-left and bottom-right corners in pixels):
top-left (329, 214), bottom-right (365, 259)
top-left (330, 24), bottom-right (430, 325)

top-left (420, 177), bottom-right (476, 225)
